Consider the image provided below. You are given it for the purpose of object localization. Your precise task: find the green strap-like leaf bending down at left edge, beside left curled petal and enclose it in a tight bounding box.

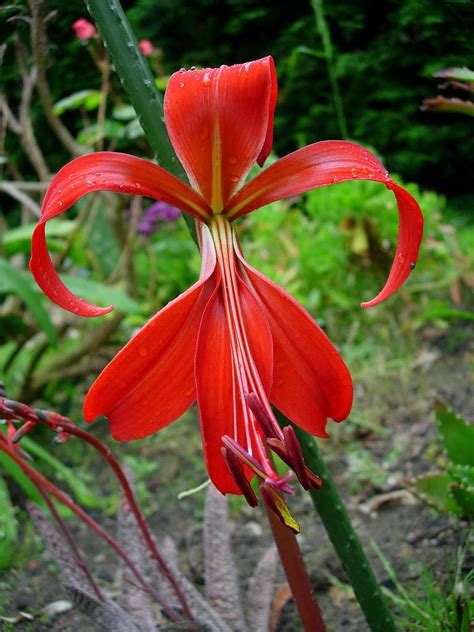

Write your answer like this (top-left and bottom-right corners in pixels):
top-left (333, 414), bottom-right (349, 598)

top-left (0, 259), bottom-right (56, 345)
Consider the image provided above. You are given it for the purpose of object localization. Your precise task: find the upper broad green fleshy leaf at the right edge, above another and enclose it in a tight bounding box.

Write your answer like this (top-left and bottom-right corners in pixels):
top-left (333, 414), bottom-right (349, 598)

top-left (436, 403), bottom-right (474, 465)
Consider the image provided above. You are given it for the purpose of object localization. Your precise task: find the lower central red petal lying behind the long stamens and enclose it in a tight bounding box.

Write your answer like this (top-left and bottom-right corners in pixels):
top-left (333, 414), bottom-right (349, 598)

top-left (195, 272), bottom-right (273, 494)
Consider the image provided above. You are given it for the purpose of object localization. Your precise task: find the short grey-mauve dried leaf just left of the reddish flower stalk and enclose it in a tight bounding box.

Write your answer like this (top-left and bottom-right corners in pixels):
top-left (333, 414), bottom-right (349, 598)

top-left (245, 548), bottom-right (278, 632)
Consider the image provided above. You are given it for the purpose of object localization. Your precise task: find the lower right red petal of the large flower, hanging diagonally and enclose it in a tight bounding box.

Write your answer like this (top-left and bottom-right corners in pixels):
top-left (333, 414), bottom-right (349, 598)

top-left (238, 244), bottom-right (353, 437)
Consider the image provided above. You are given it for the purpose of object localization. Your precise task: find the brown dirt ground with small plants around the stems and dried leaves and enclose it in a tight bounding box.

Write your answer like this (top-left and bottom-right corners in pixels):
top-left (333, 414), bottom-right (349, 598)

top-left (0, 332), bottom-right (474, 632)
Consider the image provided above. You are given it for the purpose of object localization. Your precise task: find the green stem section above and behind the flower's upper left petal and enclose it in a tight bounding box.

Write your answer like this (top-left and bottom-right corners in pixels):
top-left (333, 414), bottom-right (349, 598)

top-left (85, 0), bottom-right (197, 242)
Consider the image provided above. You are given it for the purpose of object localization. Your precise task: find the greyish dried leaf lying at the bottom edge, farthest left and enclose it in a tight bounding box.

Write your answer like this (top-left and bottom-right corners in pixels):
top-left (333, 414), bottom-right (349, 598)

top-left (64, 584), bottom-right (141, 632)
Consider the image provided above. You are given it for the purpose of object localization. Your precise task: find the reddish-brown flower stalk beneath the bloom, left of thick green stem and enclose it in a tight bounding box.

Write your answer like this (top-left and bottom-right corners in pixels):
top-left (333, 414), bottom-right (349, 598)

top-left (267, 507), bottom-right (326, 632)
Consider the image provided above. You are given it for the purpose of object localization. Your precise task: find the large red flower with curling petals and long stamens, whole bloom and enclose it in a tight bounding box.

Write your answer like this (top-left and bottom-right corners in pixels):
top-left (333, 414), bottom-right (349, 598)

top-left (31, 57), bottom-right (423, 522)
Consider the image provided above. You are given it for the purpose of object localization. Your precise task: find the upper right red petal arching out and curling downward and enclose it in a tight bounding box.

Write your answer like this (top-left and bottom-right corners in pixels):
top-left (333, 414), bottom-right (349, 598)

top-left (225, 141), bottom-right (423, 307)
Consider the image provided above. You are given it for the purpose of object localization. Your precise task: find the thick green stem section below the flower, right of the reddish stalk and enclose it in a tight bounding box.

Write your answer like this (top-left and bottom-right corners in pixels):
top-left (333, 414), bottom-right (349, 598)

top-left (295, 427), bottom-right (396, 632)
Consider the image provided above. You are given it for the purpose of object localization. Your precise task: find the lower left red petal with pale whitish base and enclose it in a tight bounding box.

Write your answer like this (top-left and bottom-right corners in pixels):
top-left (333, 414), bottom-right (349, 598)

top-left (84, 226), bottom-right (216, 441)
